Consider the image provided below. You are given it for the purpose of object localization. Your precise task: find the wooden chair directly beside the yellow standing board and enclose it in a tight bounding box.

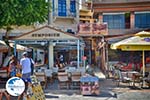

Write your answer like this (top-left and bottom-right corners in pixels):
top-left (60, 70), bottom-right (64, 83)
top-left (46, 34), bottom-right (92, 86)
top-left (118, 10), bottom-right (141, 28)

top-left (35, 72), bottom-right (47, 89)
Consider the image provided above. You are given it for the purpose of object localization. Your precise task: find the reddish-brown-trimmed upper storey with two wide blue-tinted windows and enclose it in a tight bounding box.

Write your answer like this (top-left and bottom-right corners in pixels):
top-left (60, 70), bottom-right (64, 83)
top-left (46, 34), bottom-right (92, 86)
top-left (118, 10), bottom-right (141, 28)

top-left (93, 0), bottom-right (150, 35)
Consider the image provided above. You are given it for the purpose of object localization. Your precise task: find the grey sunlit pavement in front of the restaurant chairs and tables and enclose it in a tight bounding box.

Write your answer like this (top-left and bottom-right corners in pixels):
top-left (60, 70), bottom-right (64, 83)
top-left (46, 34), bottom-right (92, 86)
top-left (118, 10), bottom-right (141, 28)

top-left (45, 70), bottom-right (150, 100)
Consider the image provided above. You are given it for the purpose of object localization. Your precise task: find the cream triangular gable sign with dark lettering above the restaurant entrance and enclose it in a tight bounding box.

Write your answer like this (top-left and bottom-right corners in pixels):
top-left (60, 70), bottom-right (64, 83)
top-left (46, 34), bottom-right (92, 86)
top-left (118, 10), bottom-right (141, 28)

top-left (15, 26), bottom-right (78, 40)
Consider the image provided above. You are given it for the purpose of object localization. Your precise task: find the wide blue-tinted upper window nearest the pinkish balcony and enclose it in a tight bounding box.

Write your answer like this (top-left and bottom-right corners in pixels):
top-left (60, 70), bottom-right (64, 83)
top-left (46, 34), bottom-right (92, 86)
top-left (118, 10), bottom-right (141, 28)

top-left (103, 14), bottom-right (125, 29)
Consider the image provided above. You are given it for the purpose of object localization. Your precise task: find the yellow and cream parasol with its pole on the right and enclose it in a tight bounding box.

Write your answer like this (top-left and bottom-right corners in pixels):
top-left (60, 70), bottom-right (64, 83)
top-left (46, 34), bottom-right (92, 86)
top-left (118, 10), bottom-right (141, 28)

top-left (111, 31), bottom-right (150, 76)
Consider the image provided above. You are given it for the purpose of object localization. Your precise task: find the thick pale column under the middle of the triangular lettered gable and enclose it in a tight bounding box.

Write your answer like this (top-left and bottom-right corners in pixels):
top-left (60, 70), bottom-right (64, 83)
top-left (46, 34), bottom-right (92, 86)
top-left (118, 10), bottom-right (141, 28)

top-left (48, 43), bottom-right (54, 68)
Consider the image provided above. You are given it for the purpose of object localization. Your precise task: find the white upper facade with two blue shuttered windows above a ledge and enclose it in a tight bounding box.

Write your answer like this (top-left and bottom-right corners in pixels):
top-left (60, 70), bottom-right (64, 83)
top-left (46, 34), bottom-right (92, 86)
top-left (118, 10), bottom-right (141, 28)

top-left (49, 0), bottom-right (79, 34)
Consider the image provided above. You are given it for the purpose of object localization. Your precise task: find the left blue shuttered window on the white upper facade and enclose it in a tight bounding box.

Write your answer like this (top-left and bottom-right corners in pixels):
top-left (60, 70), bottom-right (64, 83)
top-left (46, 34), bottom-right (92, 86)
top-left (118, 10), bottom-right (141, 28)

top-left (58, 0), bottom-right (67, 16)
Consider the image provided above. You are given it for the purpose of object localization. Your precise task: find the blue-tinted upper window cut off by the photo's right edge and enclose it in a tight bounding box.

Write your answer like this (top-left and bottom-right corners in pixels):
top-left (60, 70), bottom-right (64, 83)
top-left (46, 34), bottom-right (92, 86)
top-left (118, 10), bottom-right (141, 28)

top-left (135, 13), bottom-right (150, 28)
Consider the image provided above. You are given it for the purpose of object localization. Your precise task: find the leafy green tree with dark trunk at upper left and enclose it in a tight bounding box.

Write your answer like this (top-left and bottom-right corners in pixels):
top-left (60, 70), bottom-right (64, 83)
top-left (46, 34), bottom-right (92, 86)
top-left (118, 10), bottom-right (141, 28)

top-left (0, 0), bottom-right (49, 50)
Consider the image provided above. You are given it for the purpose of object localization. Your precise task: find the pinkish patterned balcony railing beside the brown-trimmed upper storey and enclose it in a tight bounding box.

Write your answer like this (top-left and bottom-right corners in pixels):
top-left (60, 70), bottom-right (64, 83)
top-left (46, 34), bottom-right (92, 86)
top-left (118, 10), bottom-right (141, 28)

top-left (78, 23), bottom-right (108, 34)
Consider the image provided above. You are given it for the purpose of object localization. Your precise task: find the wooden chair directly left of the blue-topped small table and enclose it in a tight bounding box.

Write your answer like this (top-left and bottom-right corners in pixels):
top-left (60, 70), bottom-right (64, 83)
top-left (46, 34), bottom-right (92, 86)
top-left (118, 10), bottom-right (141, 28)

top-left (71, 72), bottom-right (81, 89)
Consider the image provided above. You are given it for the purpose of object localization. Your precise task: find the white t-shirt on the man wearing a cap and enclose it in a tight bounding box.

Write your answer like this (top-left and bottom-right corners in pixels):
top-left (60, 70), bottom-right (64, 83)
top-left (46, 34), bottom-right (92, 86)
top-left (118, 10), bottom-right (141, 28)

top-left (20, 58), bottom-right (31, 74)
